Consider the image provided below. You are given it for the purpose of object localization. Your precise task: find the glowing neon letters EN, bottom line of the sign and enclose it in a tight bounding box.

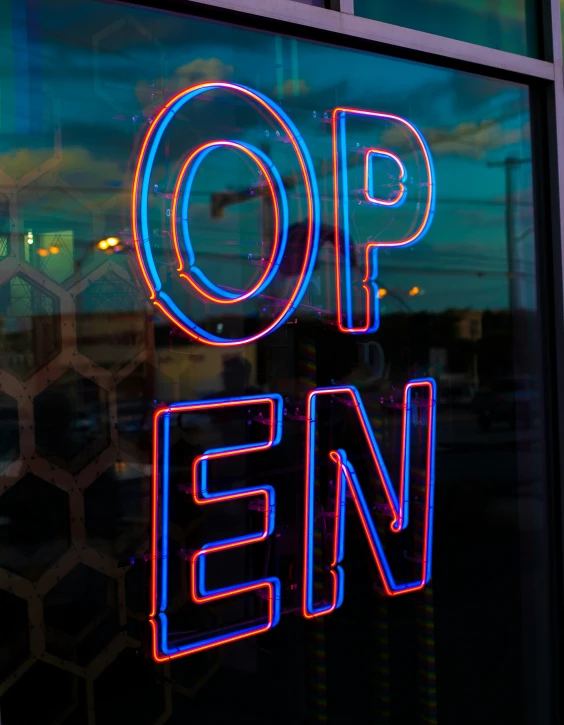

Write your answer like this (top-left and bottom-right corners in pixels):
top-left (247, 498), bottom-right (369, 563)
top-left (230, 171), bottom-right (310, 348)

top-left (150, 378), bottom-right (436, 662)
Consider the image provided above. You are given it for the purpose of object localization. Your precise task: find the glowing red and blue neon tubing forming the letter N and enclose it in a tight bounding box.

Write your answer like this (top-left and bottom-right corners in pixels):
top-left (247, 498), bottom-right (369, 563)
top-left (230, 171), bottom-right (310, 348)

top-left (302, 378), bottom-right (437, 619)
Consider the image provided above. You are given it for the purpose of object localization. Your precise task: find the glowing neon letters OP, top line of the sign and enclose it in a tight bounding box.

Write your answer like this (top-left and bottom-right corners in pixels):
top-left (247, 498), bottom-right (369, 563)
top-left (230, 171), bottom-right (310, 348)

top-left (131, 81), bottom-right (435, 347)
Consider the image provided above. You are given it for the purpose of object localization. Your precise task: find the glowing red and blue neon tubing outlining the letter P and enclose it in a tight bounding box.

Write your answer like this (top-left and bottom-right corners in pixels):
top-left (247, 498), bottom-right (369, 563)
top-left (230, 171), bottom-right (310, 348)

top-left (332, 108), bottom-right (436, 335)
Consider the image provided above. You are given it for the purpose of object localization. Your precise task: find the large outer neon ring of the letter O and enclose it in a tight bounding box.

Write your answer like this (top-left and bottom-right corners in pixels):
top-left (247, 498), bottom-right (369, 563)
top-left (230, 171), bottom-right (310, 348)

top-left (131, 81), bottom-right (320, 347)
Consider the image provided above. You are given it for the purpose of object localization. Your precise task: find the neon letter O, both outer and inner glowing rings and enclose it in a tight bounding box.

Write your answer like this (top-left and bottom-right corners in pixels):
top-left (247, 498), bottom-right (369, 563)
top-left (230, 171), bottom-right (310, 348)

top-left (131, 81), bottom-right (319, 347)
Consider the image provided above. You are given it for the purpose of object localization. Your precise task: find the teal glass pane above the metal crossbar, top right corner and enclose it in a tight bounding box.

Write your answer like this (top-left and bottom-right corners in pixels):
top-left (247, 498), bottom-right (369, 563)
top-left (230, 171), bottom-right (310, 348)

top-left (354, 0), bottom-right (542, 58)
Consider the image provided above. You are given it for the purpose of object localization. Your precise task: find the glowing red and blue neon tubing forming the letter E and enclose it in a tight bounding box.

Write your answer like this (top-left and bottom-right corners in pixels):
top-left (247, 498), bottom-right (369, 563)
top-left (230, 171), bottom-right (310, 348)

top-left (150, 394), bottom-right (283, 662)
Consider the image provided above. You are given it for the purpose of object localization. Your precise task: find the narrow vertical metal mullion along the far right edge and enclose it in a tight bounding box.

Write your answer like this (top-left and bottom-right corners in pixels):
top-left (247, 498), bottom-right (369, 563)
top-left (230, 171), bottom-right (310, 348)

top-left (533, 0), bottom-right (564, 723)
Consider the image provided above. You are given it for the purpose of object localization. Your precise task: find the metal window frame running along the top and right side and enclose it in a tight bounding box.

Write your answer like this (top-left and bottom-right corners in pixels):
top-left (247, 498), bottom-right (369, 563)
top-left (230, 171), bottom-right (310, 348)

top-left (111, 0), bottom-right (564, 723)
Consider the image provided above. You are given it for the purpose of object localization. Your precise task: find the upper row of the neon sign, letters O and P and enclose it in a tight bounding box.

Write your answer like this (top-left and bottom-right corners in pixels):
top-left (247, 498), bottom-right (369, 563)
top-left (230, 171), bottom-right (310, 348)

top-left (131, 81), bottom-right (435, 347)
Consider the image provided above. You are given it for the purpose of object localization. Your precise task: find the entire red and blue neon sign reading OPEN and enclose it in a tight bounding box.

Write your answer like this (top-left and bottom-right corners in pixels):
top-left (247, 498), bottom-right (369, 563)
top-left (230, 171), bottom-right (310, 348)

top-left (131, 81), bottom-right (437, 662)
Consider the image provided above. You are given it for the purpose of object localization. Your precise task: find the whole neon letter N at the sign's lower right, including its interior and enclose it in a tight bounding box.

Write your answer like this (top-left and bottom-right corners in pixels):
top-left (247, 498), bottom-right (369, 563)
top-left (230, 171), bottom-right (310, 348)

top-left (302, 378), bottom-right (436, 618)
